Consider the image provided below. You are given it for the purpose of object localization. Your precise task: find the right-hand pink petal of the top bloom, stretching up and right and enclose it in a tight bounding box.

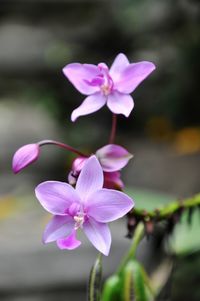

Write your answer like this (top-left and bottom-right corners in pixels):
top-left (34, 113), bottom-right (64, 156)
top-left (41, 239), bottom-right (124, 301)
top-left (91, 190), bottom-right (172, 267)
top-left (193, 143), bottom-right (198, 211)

top-left (115, 61), bottom-right (156, 94)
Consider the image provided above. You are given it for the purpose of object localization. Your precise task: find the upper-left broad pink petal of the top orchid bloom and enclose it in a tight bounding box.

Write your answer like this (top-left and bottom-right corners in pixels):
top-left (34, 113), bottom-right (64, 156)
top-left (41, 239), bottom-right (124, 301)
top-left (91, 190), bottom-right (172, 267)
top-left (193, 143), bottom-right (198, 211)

top-left (63, 63), bottom-right (100, 95)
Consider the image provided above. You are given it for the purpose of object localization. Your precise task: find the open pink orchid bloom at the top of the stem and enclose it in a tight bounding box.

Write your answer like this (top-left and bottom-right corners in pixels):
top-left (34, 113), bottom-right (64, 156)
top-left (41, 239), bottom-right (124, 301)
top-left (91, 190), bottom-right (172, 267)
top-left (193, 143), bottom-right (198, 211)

top-left (63, 53), bottom-right (155, 121)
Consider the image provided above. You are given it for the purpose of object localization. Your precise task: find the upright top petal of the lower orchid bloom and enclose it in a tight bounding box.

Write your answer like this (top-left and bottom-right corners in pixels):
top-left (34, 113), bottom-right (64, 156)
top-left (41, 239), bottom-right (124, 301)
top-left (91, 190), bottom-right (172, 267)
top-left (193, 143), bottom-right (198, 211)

top-left (76, 155), bottom-right (103, 202)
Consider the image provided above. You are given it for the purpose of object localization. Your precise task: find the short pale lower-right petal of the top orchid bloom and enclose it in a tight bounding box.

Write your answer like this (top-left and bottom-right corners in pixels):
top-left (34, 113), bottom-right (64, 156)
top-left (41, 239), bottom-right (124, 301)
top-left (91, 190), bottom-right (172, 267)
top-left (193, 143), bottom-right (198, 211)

top-left (107, 91), bottom-right (134, 117)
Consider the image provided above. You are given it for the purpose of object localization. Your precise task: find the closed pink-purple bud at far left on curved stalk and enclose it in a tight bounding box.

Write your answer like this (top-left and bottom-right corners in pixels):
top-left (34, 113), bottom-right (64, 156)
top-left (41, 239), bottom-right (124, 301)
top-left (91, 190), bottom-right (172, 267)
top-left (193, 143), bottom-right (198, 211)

top-left (12, 143), bottom-right (40, 174)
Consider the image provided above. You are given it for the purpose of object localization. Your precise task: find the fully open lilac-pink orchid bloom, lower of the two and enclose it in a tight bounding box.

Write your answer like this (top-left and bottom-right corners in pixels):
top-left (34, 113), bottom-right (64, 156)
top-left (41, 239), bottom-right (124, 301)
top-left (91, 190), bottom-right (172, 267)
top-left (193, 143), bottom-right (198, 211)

top-left (35, 155), bottom-right (134, 255)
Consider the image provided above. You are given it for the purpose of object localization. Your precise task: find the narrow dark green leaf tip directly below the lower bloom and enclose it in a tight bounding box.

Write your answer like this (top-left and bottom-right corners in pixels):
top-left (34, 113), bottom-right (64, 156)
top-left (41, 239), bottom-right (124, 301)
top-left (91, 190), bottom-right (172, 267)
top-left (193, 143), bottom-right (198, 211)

top-left (88, 254), bottom-right (102, 301)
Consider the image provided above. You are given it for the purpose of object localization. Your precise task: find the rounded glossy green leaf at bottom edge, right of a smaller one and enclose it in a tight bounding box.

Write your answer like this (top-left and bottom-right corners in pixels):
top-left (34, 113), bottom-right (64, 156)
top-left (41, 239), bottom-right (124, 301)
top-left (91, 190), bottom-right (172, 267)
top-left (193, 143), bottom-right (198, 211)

top-left (122, 260), bottom-right (147, 301)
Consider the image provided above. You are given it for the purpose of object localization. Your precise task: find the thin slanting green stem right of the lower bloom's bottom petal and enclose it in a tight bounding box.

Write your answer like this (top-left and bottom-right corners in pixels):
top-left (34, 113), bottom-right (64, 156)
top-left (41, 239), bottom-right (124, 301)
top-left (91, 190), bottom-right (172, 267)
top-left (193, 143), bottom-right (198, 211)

top-left (117, 223), bottom-right (145, 274)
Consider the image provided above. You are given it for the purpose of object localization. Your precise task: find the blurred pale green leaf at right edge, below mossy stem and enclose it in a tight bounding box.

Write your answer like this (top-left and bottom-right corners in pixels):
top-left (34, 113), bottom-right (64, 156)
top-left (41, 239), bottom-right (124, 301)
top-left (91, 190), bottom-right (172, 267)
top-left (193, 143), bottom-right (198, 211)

top-left (166, 209), bottom-right (200, 255)
